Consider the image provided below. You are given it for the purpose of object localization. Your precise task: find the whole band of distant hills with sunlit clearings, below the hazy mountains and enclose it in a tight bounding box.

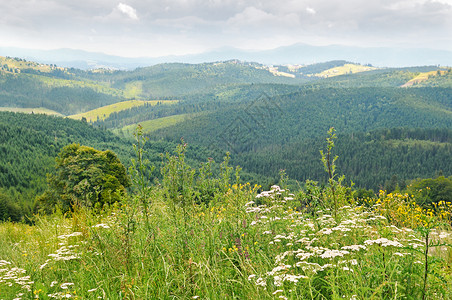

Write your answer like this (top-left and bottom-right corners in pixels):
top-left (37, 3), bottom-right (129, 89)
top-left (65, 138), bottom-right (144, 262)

top-left (0, 57), bottom-right (450, 118)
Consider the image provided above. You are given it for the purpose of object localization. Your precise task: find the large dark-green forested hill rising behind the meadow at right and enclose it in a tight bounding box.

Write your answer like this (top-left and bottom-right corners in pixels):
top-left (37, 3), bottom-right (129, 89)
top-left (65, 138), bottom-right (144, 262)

top-left (153, 88), bottom-right (452, 153)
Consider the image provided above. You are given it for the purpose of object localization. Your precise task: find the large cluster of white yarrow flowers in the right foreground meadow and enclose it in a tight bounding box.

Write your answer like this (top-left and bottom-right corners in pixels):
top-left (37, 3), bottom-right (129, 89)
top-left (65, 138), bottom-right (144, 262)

top-left (245, 186), bottom-right (440, 299)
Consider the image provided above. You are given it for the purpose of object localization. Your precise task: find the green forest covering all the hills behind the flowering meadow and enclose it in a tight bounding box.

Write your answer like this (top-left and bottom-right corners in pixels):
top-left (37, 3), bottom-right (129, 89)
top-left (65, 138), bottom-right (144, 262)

top-left (0, 58), bottom-right (452, 219)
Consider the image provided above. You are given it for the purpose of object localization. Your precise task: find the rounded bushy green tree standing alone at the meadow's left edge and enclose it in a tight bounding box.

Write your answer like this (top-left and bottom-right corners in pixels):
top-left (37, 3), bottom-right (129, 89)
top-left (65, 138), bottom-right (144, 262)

top-left (37, 144), bottom-right (130, 211)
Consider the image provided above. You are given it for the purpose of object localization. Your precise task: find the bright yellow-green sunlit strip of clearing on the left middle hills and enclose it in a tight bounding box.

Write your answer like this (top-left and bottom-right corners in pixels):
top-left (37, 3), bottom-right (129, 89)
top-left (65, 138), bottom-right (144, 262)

top-left (69, 100), bottom-right (178, 122)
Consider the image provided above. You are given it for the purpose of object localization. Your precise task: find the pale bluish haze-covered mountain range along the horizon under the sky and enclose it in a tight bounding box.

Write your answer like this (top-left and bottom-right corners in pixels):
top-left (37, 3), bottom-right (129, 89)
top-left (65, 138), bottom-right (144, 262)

top-left (0, 44), bottom-right (452, 70)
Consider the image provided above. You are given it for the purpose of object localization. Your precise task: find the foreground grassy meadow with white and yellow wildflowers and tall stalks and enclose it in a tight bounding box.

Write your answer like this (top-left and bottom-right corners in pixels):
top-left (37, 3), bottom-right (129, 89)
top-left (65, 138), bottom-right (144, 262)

top-left (0, 130), bottom-right (452, 299)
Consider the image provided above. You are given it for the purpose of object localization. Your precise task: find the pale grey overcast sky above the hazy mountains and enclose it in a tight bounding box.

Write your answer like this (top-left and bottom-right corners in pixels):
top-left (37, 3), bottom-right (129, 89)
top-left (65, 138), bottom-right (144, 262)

top-left (0, 0), bottom-right (452, 57)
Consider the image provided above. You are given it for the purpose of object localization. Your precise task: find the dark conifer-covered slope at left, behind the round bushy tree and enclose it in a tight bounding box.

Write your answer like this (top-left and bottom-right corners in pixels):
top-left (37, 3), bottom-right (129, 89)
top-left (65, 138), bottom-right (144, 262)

top-left (0, 112), bottom-right (188, 203)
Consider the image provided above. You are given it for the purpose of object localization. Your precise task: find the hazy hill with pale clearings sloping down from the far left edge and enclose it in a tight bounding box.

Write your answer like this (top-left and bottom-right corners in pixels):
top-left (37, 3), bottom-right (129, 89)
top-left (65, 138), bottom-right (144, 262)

top-left (0, 59), bottom-right (124, 115)
